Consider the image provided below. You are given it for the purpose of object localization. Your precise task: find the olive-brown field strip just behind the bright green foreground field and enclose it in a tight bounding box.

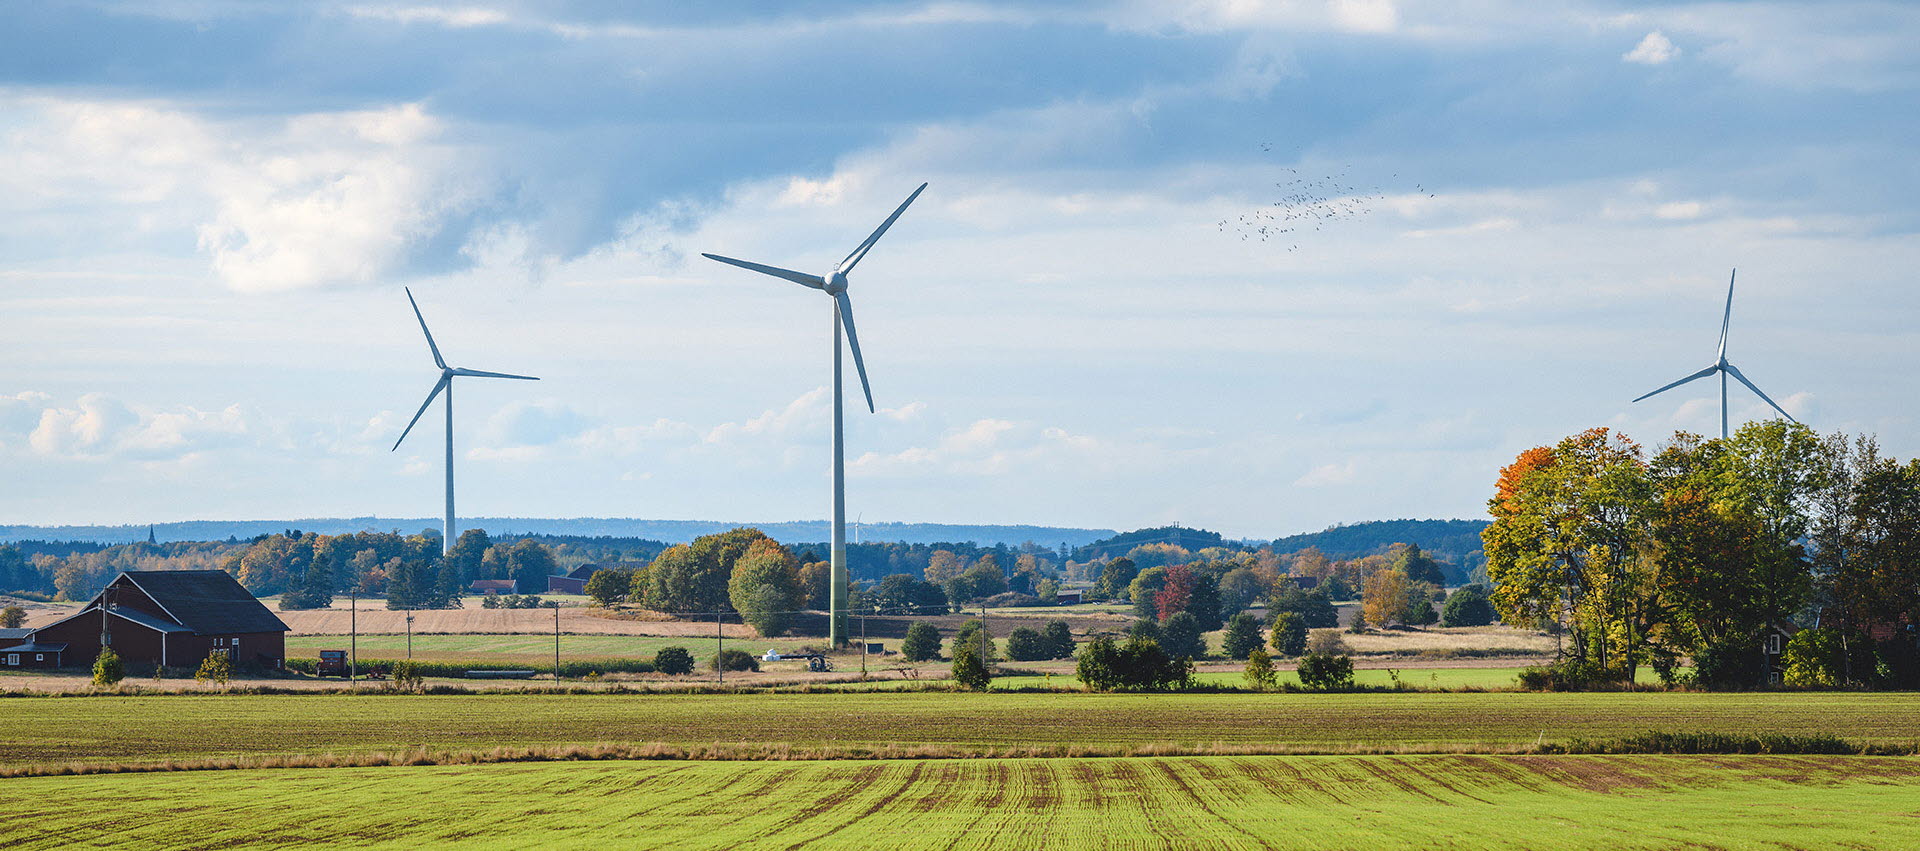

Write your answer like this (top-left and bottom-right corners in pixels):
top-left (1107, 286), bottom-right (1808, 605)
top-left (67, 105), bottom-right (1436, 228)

top-left (0, 692), bottom-right (1920, 765)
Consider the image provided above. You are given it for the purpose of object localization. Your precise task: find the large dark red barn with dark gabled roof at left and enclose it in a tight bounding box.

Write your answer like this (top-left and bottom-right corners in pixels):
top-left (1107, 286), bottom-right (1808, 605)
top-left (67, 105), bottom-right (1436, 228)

top-left (26, 571), bottom-right (288, 669)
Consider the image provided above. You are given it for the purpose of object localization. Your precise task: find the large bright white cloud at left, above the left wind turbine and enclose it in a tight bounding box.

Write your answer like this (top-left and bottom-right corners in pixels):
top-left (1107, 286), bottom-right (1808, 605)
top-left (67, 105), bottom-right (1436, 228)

top-left (0, 98), bottom-right (486, 292)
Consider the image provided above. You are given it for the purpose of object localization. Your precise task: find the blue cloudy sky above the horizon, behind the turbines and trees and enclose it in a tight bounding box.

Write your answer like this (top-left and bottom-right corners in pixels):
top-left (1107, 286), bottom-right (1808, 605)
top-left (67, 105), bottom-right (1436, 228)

top-left (0, 0), bottom-right (1920, 536)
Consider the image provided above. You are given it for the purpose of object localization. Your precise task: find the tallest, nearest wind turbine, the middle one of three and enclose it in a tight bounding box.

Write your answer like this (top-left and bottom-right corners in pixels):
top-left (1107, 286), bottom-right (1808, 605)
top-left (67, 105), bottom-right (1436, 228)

top-left (701, 182), bottom-right (927, 647)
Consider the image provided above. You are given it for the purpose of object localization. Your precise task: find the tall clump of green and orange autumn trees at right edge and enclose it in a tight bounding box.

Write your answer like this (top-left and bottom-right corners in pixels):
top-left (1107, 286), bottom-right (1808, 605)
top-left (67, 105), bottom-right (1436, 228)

top-left (1482, 421), bottom-right (1920, 688)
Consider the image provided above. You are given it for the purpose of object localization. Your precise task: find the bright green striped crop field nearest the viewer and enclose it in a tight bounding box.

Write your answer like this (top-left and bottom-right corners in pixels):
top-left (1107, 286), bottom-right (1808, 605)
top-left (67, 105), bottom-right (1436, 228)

top-left (0, 756), bottom-right (1920, 849)
